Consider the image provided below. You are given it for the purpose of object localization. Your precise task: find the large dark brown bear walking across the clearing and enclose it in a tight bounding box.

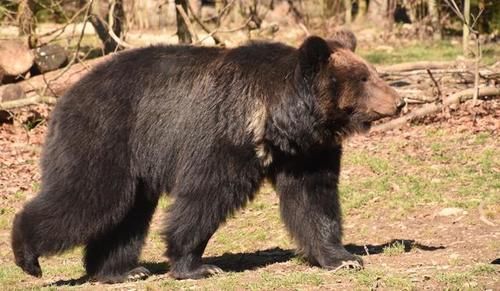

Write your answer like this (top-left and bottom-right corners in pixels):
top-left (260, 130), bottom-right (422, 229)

top-left (11, 33), bottom-right (404, 283)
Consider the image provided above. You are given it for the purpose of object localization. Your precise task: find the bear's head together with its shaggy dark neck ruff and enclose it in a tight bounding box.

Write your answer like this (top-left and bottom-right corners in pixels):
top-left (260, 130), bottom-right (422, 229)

top-left (262, 31), bottom-right (404, 154)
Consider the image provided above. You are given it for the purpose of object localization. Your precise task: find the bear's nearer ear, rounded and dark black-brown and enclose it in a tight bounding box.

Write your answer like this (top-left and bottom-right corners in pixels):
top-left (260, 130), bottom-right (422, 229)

top-left (299, 36), bottom-right (332, 74)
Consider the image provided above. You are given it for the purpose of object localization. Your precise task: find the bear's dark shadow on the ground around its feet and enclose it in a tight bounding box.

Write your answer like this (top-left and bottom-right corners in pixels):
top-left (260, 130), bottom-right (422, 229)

top-left (46, 239), bottom-right (445, 287)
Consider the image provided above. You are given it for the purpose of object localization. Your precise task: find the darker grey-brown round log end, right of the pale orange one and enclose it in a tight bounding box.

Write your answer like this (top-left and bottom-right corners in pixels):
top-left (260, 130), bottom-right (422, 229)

top-left (34, 44), bottom-right (68, 73)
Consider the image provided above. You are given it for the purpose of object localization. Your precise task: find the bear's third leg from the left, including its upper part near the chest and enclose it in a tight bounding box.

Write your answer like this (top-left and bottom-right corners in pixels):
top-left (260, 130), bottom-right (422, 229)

top-left (164, 148), bottom-right (262, 279)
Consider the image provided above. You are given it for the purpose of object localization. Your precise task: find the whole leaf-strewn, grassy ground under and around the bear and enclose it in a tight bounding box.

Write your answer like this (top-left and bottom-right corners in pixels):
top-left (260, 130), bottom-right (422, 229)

top-left (0, 100), bottom-right (500, 290)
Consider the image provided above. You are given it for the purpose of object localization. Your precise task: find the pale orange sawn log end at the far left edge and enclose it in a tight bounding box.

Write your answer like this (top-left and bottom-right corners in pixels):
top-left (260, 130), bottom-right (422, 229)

top-left (0, 40), bottom-right (35, 77)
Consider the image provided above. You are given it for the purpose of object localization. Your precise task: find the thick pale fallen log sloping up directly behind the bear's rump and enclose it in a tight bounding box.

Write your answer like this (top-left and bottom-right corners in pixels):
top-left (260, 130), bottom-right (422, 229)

top-left (17, 54), bottom-right (113, 97)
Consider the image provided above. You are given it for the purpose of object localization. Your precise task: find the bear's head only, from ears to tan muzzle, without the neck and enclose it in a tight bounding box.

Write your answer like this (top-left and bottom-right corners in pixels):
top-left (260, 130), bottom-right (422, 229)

top-left (295, 31), bottom-right (404, 139)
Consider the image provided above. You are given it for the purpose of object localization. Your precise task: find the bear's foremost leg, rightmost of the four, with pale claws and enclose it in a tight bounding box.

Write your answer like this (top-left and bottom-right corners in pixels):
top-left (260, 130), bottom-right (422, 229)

top-left (273, 147), bottom-right (363, 270)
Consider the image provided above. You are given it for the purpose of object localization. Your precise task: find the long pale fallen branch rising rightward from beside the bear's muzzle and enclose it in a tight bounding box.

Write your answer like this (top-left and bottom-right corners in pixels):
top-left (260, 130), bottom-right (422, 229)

top-left (372, 87), bottom-right (500, 132)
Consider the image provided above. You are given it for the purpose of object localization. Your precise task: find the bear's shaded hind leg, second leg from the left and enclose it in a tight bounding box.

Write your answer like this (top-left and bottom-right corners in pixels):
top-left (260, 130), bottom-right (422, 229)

top-left (84, 185), bottom-right (158, 283)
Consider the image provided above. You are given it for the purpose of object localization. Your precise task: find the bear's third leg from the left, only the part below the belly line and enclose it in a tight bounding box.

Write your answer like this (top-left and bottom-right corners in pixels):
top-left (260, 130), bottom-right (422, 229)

top-left (165, 183), bottom-right (256, 279)
